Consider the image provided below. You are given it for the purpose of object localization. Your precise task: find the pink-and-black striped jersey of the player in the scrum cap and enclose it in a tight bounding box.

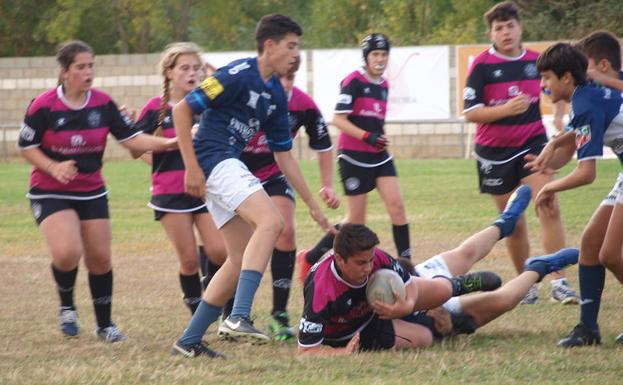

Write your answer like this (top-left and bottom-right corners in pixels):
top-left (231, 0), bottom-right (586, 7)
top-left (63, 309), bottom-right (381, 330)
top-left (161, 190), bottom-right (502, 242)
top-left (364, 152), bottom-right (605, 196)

top-left (335, 68), bottom-right (391, 167)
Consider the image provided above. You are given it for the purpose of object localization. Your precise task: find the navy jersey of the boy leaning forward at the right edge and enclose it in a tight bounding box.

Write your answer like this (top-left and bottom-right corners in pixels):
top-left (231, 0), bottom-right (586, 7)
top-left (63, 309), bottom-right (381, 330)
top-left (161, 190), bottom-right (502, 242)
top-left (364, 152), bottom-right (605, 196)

top-left (566, 84), bottom-right (623, 163)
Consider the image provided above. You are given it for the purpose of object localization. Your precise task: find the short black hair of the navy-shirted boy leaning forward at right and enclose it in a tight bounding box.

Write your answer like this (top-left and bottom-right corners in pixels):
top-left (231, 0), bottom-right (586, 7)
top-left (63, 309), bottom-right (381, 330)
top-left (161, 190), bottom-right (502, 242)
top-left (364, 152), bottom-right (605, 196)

top-left (536, 43), bottom-right (588, 85)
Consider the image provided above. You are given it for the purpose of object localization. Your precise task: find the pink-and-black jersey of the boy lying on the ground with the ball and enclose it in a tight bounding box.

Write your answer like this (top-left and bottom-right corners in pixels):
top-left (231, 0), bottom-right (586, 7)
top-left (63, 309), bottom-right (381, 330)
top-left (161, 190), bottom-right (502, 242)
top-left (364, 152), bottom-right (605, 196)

top-left (299, 249), bottom-right (411, 347)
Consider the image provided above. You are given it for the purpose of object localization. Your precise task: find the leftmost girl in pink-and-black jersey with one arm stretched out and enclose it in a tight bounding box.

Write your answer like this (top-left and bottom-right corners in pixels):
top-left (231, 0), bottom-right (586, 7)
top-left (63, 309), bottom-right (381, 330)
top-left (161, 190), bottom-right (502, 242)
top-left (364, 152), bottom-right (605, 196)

top-left (18, 41), bottom-right (177, 342)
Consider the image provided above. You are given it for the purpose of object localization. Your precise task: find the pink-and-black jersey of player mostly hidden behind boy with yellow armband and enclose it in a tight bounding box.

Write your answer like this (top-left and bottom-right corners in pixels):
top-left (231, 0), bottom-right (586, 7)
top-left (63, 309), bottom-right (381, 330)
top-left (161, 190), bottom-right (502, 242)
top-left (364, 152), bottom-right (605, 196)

top-left (240, 87), bottom-right (333, 182)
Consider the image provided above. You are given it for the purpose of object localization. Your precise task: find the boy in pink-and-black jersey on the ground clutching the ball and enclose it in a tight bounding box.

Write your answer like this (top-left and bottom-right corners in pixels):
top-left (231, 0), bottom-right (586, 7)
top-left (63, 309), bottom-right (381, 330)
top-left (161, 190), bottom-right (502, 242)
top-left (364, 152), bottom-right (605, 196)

top-left (298, 224), bottom-right (499, 355)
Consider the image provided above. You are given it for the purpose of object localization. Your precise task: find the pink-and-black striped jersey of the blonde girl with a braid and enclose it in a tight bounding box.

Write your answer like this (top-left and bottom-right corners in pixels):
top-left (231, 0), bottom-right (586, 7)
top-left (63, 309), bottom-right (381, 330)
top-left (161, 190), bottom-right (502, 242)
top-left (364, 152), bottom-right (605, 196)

top-left (135, 96), bottom-right (205, 212)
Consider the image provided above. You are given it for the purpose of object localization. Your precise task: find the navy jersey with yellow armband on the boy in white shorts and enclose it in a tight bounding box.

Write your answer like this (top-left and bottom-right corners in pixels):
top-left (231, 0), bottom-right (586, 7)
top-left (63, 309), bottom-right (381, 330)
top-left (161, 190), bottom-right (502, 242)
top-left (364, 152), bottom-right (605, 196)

top-left (185, 58), bottom-right (292, 177)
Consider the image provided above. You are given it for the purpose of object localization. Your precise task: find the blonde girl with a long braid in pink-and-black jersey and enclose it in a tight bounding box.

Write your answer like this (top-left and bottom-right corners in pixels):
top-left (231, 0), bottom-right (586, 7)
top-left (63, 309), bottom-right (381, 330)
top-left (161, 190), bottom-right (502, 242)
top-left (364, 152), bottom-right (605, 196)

top-left (136, 43), bottom-right (227, 313)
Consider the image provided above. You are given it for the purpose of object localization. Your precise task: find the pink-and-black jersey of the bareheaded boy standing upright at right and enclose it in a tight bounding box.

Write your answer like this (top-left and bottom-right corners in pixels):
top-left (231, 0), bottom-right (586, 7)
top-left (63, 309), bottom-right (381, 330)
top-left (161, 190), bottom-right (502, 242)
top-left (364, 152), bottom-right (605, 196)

top-left (463, 47), bottom-right (545, 151)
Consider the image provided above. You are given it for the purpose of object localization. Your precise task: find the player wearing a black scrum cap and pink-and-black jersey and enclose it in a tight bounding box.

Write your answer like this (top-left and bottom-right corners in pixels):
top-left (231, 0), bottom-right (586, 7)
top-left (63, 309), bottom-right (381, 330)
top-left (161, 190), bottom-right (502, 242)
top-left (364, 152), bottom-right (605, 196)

top-left (299, 33), bottom-right (411, 279)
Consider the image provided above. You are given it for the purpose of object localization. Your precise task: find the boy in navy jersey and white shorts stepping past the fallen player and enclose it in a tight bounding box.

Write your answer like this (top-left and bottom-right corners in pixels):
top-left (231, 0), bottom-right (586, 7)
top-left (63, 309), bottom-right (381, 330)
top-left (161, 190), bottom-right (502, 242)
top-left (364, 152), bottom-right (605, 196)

top-left (173, 14), bottom-right (331, 357)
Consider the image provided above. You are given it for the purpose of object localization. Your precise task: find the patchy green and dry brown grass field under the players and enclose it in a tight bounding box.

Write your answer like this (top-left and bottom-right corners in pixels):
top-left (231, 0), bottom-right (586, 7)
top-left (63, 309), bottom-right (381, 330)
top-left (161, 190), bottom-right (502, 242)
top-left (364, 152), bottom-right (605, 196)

top-left (0, 160), bottom-right (623, 384)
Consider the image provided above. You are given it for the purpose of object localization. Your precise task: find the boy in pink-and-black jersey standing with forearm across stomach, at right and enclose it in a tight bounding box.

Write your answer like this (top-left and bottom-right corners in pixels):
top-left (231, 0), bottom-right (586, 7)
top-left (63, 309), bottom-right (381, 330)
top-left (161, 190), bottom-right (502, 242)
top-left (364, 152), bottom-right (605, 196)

top-left (463, 1), bottom-right (577, 303)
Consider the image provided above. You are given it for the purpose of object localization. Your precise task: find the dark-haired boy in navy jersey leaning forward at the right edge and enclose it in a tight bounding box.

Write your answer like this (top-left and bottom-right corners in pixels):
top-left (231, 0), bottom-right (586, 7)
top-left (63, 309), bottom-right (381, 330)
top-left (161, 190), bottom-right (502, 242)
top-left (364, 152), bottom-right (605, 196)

top-left (527, 43), bottom-right (623, 347)
